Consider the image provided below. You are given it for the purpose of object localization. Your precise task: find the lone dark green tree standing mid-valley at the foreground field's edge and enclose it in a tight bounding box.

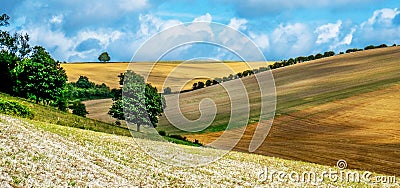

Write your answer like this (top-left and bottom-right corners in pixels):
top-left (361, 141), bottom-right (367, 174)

top-left (108, 71), bottom-right (165, 132)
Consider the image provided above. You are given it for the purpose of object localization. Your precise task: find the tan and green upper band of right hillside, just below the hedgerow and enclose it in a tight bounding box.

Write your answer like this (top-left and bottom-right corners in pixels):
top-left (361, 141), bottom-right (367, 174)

top-left (158, 47), bottom-right (400, 134)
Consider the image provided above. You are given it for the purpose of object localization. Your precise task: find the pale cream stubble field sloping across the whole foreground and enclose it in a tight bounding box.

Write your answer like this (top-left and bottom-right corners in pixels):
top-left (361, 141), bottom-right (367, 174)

top-left (0, 115), bottom-right (399, 187)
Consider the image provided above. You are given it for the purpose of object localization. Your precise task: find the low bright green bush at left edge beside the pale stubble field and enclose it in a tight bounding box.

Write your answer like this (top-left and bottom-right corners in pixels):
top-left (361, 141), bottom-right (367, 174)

top-left (0, 99), bottom-right (34, 119)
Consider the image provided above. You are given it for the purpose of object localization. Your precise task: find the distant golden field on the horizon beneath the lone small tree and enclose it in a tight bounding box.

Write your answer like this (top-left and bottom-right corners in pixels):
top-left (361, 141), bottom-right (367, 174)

top-left (61, 62), bottom-right (267, 91)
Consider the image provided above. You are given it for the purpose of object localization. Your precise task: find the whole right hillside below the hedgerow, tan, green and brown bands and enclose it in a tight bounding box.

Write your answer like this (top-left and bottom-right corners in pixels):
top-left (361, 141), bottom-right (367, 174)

top-left (155, 47), bottom-right (400, 175)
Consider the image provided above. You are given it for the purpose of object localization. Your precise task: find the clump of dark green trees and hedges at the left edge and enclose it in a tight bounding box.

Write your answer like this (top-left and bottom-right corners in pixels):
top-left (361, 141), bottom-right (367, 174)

top-left (0, 14), bottom-right (115, 116)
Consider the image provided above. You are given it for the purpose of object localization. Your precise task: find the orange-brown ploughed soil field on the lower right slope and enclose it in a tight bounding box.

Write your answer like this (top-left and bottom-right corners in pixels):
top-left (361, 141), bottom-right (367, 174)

top-left (186, 84), bottom-right (400, 175)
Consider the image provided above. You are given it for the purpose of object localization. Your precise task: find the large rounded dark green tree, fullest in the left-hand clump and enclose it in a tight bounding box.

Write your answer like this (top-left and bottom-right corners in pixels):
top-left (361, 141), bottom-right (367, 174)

top-left (17, 46), bottom-right (67, 103)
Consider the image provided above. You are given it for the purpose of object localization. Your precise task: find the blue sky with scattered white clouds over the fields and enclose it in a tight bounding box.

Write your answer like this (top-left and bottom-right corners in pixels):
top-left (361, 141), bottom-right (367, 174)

top-left (0, 0), bottom-right (400, 62)
